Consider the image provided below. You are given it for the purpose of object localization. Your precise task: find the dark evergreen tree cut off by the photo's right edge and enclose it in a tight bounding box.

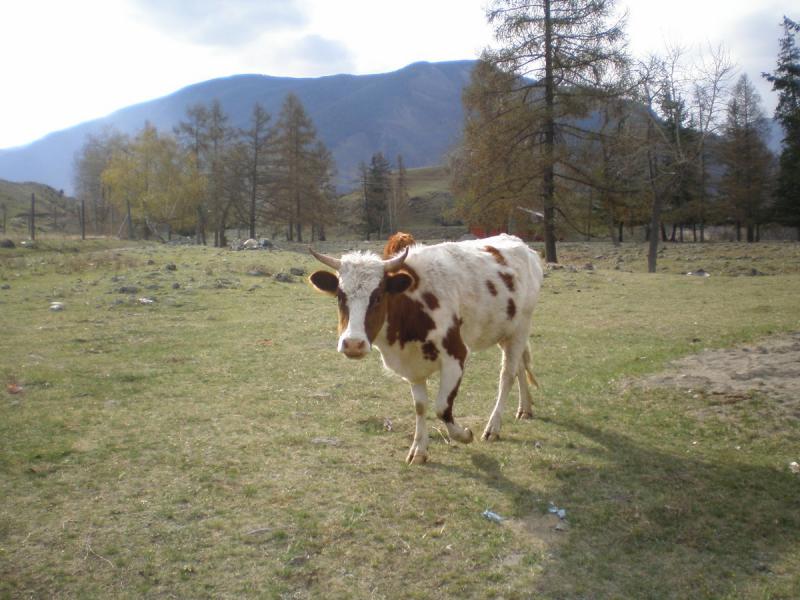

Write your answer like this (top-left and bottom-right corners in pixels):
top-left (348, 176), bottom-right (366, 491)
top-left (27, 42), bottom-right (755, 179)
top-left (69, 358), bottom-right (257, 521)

top-left (762, 17), bottom-right (800, 239)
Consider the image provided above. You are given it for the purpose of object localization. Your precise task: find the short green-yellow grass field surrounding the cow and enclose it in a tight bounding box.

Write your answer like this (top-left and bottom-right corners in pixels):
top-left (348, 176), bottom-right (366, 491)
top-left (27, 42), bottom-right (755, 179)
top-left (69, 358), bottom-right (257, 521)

top-left (0, 242), bottom-right (800, 599)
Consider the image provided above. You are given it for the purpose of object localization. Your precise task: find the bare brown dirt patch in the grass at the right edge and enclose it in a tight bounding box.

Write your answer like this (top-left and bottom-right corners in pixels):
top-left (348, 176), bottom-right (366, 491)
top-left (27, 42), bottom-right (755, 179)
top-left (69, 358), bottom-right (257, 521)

top-left (642, 332), bottom-right (800, 417)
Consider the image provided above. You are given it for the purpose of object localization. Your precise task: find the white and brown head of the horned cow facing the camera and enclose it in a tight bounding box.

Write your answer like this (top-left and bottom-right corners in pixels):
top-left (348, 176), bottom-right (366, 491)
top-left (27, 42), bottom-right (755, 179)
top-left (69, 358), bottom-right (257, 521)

top-left (309, 248), bottom-right (414, 358)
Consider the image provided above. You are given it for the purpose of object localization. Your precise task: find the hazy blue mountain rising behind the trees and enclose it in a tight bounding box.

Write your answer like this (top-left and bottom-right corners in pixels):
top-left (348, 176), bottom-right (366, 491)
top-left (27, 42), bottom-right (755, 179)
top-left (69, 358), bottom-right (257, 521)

top-left (0, 61), bottom-right (475, 193)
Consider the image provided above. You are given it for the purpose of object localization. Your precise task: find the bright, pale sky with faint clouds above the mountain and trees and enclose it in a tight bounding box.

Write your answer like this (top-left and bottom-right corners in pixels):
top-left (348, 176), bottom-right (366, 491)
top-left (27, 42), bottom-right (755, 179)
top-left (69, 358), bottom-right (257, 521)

top-left (0, 0), bottom-right (800, 149)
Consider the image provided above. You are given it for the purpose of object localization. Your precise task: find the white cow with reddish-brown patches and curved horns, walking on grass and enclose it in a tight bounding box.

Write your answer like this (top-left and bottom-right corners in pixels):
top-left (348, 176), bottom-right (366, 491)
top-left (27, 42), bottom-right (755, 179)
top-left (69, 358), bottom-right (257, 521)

top-left (310, 234), bottom-right (542, 463)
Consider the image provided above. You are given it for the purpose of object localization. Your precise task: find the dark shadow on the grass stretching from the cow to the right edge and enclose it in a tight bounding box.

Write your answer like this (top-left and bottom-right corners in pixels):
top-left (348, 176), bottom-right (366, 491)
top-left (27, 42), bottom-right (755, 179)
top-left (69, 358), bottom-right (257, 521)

top-left (434, 419), bottom-right (800, 597)
